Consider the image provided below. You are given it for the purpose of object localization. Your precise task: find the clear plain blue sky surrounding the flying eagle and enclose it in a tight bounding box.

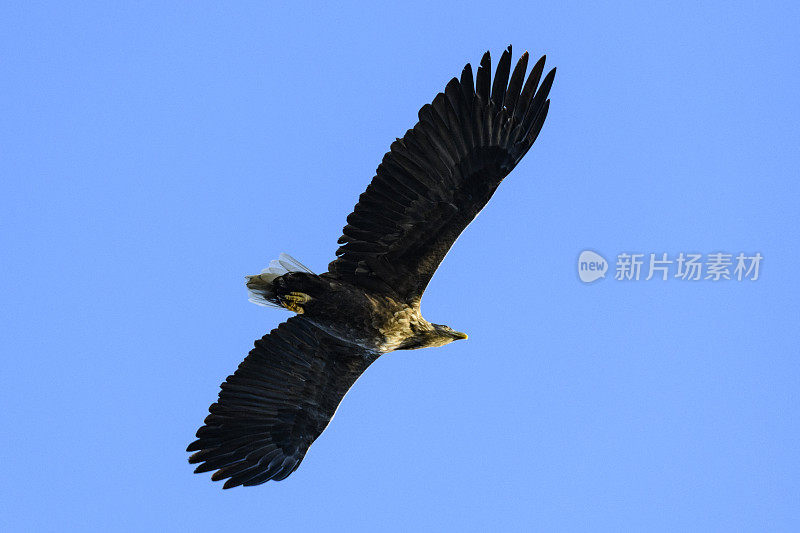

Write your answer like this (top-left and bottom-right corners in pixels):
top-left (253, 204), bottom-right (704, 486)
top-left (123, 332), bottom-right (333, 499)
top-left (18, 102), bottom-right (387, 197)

top-left (0, 1), bottom-right (800, 531)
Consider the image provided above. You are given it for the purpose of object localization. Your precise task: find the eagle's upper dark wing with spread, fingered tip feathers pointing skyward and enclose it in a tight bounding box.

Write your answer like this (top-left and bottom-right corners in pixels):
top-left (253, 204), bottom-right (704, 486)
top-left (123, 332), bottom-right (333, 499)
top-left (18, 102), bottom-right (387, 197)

top-left (327, 46), bottom-right (555, 302)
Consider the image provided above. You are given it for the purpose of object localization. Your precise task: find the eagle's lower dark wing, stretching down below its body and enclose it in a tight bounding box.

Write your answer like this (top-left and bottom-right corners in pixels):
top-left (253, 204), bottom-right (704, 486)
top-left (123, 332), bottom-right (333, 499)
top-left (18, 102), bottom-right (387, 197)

top-left (186, 317), bottom-right (378, 489)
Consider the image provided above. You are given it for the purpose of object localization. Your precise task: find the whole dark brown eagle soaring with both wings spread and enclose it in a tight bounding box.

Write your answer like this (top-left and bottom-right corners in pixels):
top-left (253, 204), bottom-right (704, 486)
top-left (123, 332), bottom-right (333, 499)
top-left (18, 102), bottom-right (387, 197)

top-left (187, 46), bottom-right (555, 489)
